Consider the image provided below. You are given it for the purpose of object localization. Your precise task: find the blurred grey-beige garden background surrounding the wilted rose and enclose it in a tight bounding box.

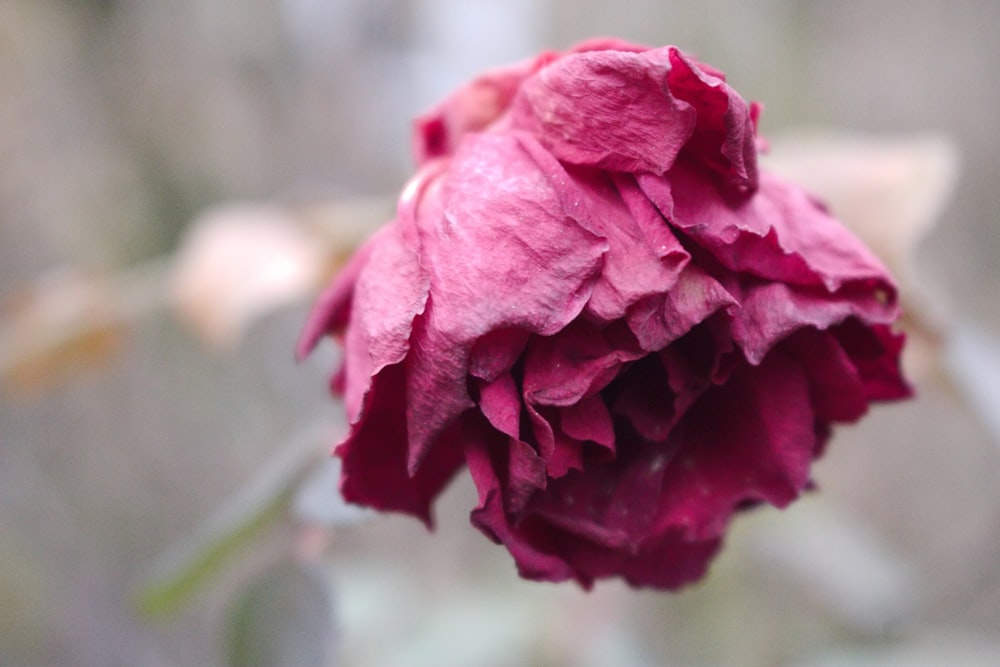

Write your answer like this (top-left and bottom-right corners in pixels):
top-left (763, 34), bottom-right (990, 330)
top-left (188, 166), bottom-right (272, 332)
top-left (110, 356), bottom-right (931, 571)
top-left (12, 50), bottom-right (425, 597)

top-left (0, 0), bottom-right (1000, 667)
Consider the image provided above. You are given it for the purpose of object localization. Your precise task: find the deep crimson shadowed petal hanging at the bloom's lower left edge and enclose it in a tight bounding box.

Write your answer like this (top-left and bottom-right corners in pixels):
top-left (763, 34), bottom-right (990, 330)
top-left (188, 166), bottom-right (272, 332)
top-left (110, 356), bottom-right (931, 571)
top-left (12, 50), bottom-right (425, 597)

top-left (336, 364), bottom-right (462, 526)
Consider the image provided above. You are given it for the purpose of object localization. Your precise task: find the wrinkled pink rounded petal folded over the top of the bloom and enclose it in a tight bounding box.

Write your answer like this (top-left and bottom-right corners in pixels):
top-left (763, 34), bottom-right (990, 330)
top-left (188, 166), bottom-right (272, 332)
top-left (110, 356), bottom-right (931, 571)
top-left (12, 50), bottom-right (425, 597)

top-left (510, 48), bottom-right (696, 174)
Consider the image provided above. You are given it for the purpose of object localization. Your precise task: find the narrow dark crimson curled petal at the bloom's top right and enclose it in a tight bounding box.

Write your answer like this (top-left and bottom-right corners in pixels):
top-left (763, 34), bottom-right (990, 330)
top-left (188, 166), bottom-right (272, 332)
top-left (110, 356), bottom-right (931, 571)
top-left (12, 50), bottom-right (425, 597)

top-left (668, 48), bottom-right (757, 196)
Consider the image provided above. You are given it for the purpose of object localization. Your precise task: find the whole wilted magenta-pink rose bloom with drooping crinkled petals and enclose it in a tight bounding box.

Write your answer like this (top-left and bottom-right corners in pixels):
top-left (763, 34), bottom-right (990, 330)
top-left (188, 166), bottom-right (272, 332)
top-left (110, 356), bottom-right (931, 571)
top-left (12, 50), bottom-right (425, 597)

top-left (299, 41), bottom-right (909, 589)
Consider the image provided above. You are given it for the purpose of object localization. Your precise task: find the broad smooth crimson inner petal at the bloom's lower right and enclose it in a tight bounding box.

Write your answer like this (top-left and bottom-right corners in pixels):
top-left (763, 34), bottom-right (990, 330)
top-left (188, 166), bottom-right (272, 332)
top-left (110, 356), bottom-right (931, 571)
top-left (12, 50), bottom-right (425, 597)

top-left (655, 350), bottom-right (816, 540)
